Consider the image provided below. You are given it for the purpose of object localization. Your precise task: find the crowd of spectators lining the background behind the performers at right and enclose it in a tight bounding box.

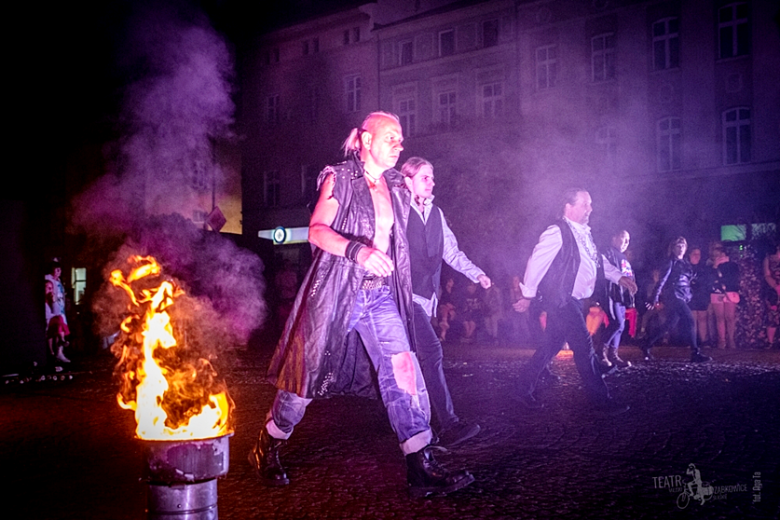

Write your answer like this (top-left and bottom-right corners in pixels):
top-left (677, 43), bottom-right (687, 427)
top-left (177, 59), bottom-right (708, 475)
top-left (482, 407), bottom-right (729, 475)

top-left (420, 241), bottom-right (780, 349)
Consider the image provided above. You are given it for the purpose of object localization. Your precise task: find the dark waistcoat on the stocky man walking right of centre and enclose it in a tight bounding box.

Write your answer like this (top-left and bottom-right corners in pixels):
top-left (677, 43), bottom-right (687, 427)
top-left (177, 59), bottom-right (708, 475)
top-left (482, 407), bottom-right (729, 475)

top-left (538, 219), bottom-right (580, 307)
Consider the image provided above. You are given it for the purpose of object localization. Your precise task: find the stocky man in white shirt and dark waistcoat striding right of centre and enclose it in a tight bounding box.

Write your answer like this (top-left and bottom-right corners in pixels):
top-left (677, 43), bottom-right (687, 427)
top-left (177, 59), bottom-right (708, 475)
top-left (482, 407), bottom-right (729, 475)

top-left (514, 188), bottom-right (637, 413)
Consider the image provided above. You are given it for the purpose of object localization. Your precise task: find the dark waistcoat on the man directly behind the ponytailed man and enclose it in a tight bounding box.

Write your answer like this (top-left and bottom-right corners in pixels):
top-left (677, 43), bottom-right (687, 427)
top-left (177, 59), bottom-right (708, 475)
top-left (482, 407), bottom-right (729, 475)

top-left (406, 206), bottom-right (444, 299)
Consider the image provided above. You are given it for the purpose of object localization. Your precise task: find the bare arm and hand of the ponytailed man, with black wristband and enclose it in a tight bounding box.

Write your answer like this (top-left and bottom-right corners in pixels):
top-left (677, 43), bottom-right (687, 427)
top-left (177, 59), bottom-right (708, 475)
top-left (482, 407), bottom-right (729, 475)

top-left (309, 174), bottom-right (393, 276)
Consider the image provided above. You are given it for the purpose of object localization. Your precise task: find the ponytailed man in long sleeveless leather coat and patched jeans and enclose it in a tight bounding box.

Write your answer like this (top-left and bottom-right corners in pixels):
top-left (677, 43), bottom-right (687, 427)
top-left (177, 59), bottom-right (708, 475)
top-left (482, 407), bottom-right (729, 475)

top-left (249, 112), bottom-right (474, 497)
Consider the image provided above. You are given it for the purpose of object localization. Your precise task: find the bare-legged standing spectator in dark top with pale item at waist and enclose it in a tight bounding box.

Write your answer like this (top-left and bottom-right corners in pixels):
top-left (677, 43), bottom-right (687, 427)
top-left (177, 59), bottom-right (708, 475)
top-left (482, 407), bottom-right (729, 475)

top-left (710, 244), bottom-right (739, 349)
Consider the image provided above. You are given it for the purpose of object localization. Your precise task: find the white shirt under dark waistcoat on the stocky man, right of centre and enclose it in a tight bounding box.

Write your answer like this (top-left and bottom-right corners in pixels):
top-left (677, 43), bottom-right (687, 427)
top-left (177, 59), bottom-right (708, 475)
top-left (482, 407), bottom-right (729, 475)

top-left (520, 217), bottom-right (622, 300)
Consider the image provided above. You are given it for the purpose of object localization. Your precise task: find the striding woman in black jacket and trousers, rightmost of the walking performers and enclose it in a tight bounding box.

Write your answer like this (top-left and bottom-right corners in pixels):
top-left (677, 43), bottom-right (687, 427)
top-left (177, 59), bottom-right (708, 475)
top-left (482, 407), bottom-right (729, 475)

top-left (641, 237), bottom-right (712, 363)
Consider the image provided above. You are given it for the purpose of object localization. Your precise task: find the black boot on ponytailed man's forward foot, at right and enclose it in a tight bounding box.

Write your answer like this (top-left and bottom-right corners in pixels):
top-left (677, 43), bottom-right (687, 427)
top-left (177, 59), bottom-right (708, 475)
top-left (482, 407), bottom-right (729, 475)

top-left (406, 444), bottom-right (474, 498)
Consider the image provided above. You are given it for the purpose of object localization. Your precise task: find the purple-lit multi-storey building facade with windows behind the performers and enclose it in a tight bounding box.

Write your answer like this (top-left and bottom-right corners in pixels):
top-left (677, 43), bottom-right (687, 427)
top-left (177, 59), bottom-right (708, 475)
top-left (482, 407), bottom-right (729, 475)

top-left (241, 0), bottom-right (780, 270)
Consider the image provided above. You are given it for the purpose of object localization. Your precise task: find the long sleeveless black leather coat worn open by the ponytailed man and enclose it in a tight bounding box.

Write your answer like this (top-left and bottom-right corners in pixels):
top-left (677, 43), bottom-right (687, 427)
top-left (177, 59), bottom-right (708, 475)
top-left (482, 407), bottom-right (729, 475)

top-left (268, 157), bottom-right (414, 398)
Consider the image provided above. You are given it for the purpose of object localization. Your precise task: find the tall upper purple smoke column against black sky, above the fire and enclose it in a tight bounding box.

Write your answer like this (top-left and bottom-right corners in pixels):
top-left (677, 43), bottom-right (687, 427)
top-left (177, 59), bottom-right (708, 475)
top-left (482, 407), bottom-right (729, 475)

top-left (71, 0), bottom-right (235, 235)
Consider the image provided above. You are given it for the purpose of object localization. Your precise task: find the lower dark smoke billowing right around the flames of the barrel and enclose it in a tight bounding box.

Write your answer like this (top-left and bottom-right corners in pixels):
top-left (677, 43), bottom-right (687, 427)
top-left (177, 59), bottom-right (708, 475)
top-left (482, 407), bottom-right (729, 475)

top-left (92, 214), bottom-right (267, 347)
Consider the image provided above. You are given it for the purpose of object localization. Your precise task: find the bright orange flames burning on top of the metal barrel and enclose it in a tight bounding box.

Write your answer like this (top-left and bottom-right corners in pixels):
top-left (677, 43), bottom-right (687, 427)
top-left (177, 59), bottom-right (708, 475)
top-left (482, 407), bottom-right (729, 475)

top-left (110, 256), bottom-right (232, 440)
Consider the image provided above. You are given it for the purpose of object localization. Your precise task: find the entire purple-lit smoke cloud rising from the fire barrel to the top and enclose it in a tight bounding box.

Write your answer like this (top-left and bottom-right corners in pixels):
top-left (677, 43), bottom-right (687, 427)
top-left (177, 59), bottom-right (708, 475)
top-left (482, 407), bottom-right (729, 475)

top-left (70, 2), bottom-right (266, 345)
